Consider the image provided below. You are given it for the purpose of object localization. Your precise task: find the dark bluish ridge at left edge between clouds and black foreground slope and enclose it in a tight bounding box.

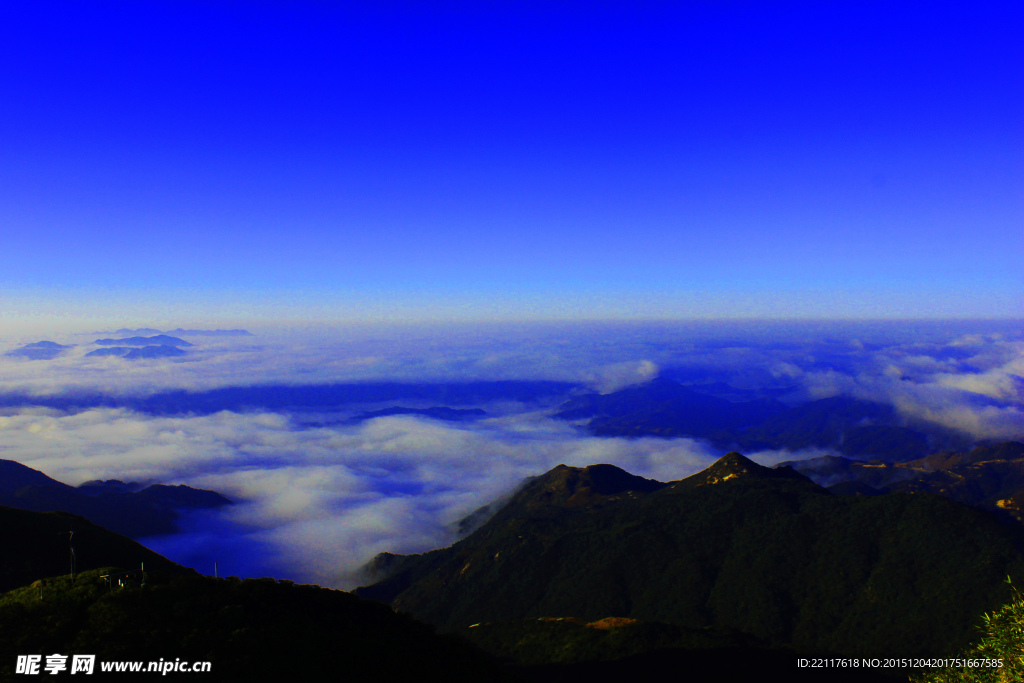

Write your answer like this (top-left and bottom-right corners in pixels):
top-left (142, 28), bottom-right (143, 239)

top-left (0, 460), bottom-right (231, 539)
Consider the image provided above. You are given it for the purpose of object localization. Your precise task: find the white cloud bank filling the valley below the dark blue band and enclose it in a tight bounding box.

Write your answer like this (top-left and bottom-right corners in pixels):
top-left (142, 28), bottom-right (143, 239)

top-left (0, 409), bottom-right (715, 587)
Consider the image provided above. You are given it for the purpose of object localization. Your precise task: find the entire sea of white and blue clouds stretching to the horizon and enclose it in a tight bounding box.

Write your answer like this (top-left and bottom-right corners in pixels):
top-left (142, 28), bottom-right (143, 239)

top-left (0, 322), bottom-right (1024, 588)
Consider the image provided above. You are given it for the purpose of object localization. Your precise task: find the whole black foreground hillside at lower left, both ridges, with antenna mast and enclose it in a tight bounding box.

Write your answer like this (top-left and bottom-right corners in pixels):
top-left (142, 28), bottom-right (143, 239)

top-left (0, 518), bottom-right (515, 683)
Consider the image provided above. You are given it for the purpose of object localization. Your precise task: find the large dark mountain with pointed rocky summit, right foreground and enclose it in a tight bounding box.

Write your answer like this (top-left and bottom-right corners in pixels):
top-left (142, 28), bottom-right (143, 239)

top-left (360, 453), bottom-right (1024, 660)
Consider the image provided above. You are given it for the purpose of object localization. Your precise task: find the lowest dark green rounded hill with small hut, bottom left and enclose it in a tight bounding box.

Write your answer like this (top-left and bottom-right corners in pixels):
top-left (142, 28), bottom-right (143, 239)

top-left (0, 569), bottom-right (508, 682)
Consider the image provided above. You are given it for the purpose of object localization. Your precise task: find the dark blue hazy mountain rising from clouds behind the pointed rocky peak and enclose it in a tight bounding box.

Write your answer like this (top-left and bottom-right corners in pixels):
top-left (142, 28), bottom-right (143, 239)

top-left (554, 378), bottom-right (955, 462)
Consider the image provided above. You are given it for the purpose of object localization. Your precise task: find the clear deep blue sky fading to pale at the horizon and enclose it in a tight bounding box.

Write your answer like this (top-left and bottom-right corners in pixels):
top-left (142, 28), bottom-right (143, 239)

top-left (0, 0), bottom-right (1024, 326)
